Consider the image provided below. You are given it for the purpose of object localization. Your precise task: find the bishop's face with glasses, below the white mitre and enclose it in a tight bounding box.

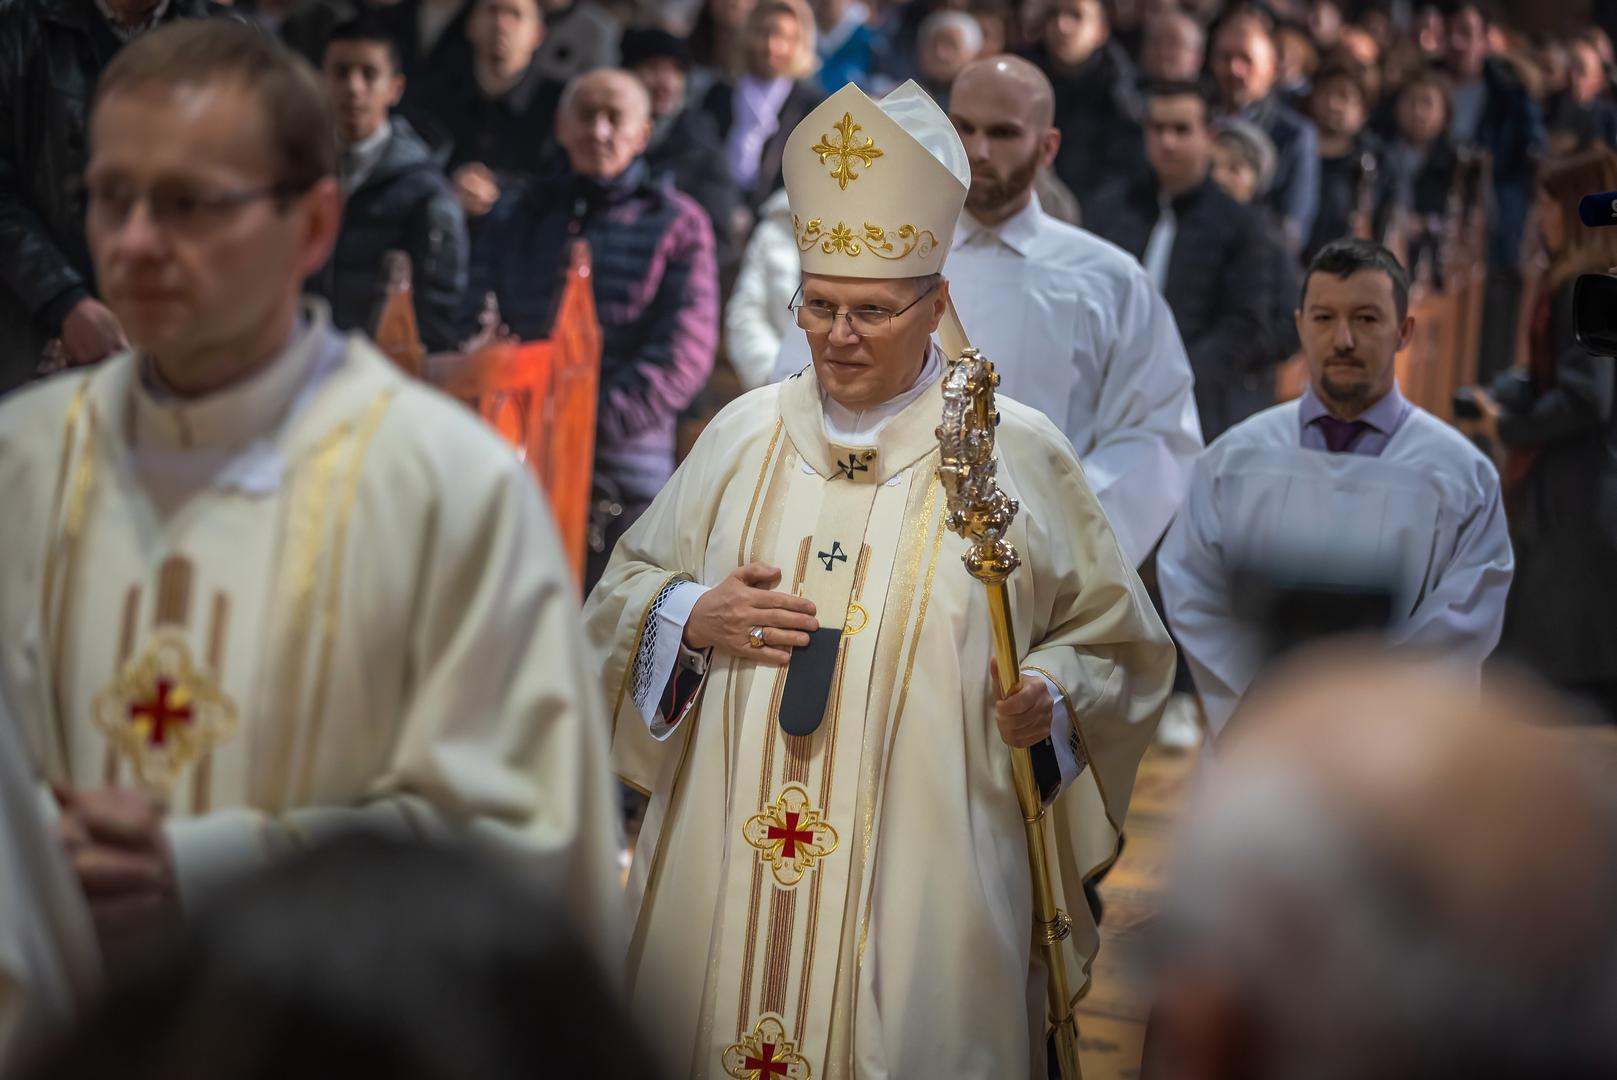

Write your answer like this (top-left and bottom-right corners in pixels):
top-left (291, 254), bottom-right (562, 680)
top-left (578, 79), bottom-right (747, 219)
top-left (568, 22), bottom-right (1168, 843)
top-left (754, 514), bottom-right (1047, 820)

top-left (799, 273), bottom-right (949, 411)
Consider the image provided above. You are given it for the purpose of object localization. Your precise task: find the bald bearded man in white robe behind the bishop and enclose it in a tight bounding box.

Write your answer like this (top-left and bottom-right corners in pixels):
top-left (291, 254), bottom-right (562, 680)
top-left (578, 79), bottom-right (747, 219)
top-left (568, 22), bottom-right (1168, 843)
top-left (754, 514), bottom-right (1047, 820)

top-left (776, 57), bottom-right (1201, 566)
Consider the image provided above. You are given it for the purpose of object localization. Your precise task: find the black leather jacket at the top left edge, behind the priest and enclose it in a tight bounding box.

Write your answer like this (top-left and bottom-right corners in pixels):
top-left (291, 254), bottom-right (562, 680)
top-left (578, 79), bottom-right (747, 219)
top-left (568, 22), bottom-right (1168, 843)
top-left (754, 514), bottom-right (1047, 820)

top-left (0, 0), bottom-right (223, 393)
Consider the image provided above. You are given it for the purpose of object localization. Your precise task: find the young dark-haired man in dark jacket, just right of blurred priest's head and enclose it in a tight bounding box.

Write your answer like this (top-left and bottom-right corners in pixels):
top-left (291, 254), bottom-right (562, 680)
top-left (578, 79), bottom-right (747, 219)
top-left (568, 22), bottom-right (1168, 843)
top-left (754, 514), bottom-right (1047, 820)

top-left (310, 16), bottom-right (467, 349)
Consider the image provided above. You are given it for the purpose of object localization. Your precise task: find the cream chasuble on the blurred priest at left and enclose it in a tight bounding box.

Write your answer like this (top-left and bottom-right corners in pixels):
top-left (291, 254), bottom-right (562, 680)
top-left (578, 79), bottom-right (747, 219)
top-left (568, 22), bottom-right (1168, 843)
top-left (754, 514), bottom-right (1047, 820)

top-left (0, 307), bottom-right (621, 957)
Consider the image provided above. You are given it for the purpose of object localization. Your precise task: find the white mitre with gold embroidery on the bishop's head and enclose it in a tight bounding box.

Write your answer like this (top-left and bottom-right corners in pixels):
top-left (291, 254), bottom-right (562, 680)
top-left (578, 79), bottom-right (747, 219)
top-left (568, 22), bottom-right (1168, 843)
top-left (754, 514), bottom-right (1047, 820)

top-left (781, 81), bottom-right (972, 278)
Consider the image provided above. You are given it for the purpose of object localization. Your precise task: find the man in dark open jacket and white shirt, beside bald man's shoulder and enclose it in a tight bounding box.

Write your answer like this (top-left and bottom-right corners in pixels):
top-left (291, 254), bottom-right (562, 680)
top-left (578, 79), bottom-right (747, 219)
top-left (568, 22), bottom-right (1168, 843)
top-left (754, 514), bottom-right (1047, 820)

top-left (1083, 82), bottom-right (1274, 443)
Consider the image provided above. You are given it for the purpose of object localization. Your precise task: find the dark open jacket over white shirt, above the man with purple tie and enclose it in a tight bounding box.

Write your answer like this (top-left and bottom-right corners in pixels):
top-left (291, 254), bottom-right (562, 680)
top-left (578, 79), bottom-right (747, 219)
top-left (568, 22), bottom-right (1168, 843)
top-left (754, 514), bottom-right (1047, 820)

top-left (1083, 172), bottom-right (1277, 443)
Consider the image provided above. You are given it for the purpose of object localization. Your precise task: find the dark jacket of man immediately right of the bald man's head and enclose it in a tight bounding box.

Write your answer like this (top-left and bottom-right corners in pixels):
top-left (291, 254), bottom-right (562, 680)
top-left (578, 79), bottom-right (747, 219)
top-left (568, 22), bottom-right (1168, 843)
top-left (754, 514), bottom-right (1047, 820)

top-left (1025, 40), bottom-right (1150, 217)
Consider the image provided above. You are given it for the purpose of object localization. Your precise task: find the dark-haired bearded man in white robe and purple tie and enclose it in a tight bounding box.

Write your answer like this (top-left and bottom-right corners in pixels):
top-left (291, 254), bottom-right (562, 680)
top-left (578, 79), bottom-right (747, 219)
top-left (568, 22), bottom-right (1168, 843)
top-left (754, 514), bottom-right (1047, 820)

top-left (1158, 239), bottom-right (1514, 732)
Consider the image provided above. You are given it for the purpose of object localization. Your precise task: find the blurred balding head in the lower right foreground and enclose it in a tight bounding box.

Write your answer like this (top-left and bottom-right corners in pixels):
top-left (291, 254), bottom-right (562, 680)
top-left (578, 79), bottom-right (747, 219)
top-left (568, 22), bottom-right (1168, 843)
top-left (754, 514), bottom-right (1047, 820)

top-left (1142, 647), bottom-right (1617, 1080)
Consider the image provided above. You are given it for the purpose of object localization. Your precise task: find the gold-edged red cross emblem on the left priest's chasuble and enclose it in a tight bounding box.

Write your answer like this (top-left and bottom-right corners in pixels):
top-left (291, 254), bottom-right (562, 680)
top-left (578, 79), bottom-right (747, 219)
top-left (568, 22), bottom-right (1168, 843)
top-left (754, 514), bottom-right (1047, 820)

top-left (94, 629), bottom-right (238, 792)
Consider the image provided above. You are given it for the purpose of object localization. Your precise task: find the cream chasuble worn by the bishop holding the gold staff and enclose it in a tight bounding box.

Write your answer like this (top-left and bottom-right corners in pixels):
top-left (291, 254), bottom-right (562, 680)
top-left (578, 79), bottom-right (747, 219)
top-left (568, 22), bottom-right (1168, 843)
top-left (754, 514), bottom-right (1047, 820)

top-left (585, 369), bottom-right (1174, 1080)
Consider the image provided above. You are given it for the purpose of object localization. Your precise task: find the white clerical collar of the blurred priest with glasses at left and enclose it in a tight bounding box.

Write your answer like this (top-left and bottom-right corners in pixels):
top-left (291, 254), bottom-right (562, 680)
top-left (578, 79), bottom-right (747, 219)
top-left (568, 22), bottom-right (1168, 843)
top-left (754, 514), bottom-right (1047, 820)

top-left (129, 299), bottom-right (333, 451)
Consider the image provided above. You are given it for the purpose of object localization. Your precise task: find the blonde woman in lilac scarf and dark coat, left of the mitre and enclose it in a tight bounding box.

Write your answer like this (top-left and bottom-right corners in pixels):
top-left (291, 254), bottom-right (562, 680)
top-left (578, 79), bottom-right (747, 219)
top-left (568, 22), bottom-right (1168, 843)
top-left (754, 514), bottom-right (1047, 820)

top-left (702, 0), bottom-right (825, 210)
